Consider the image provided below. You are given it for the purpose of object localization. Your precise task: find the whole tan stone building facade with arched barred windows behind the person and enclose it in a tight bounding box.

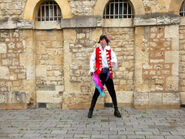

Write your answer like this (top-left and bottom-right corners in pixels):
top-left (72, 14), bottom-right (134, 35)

top-left (0, 0), bottom-right (185, 109)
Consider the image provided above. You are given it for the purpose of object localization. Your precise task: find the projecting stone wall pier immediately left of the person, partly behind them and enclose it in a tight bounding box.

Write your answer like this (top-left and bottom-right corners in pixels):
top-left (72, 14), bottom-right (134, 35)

top-left (63, 28), bottom-right (104, 109)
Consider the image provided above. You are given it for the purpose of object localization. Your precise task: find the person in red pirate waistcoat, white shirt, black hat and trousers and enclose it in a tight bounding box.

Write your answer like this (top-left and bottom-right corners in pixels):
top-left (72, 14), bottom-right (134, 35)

top-left (88, 35), bottom-right (121, 118)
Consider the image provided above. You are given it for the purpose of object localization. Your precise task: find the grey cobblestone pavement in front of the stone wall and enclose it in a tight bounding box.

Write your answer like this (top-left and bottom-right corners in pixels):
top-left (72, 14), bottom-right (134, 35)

top-left (0, 107), bottom-right (185, 139)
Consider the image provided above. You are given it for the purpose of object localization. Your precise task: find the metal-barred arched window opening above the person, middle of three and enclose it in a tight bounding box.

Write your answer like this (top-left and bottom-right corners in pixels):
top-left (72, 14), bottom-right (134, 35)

top-left (103, 0), bottom-right (134, 19)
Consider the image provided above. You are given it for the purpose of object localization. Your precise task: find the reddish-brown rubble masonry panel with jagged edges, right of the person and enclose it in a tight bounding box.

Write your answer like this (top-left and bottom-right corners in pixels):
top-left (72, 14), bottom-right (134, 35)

top-left (142, 26), bottom-right (172, 91)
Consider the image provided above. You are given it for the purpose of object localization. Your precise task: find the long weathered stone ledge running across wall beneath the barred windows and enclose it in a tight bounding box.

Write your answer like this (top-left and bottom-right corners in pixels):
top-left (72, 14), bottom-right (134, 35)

top-left (0, 13), bottom-right (181, 29)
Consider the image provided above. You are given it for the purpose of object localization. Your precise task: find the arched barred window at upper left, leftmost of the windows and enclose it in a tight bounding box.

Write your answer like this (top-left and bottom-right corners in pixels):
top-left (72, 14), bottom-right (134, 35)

top-left (36, 1), bottom-right (62, 21)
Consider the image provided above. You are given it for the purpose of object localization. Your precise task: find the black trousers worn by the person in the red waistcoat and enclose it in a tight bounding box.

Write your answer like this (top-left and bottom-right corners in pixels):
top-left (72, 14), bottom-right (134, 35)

top-left (90, 73), bottom-right (117, 110)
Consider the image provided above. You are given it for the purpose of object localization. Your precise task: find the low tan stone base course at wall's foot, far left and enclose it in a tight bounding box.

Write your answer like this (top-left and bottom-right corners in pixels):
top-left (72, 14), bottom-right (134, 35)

top-left (0, 103), bottom-right (27, 110)
